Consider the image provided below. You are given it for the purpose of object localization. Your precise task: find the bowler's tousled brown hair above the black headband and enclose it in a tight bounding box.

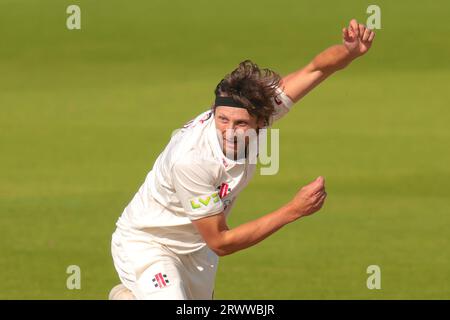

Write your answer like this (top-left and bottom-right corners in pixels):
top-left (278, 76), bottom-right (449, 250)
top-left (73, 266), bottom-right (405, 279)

top-left (213, 60), bottom-right (281, 125)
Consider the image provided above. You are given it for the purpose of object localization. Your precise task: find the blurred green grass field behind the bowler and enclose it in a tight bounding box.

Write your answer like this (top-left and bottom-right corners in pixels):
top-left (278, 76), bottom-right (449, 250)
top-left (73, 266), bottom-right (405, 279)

top-left (0, 0), bottom-right (450, 299)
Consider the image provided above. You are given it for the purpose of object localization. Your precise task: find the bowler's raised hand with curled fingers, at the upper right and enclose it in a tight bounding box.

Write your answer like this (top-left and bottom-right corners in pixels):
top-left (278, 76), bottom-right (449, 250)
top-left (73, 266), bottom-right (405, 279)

top-left (342, 19), bottom-right (375, 57)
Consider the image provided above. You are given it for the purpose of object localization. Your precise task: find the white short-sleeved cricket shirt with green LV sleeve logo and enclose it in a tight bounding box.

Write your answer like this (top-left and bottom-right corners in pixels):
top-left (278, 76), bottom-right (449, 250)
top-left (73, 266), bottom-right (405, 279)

top-left (117, 88), bottom-right (293, 254)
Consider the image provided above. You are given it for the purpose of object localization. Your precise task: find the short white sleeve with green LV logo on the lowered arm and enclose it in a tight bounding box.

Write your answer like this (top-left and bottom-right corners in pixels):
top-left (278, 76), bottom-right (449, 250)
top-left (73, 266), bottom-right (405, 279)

top-left (172, 161), bottom-right (224, 220)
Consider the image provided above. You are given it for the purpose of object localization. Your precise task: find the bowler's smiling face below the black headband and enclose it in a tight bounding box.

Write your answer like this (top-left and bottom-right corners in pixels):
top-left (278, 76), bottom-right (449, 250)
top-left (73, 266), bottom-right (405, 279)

top-left (214, 106), bottom-right (262, 160)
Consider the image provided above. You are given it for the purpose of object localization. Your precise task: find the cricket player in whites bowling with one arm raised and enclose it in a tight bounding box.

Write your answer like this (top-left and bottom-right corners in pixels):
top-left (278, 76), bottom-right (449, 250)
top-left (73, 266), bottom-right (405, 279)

top-left (109, 19), bottom-right (375, 300)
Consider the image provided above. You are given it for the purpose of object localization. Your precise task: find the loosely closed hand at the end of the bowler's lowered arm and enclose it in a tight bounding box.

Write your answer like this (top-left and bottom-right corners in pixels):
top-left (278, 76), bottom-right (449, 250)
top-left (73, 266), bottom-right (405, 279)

top-left (290, 177), bottom-right (327, 219)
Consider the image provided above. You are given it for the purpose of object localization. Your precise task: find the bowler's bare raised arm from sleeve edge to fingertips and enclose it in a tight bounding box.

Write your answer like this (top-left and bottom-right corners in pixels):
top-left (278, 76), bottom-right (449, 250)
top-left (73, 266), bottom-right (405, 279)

top-left (281, 19), bottom-right (375, 103)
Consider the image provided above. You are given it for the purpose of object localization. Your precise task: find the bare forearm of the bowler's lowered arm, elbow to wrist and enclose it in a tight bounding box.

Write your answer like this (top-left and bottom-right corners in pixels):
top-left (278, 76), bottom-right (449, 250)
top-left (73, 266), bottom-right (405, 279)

top-left (215, 204), bottom-right (295, 256)
